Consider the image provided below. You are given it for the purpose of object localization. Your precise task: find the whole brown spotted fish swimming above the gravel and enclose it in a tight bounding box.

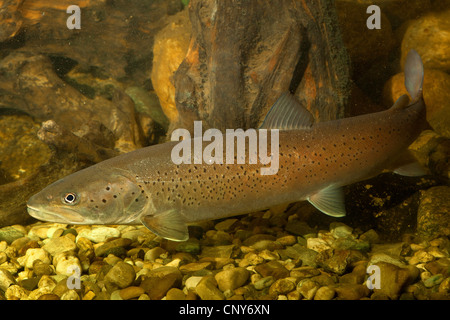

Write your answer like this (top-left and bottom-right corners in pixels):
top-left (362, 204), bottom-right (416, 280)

top-left (27, 50), bottom-right (427, 241)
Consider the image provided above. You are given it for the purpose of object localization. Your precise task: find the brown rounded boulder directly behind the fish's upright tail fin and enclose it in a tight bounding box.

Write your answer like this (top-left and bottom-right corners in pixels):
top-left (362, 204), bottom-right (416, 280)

top-left (383, 68), bottom-right (450, 138)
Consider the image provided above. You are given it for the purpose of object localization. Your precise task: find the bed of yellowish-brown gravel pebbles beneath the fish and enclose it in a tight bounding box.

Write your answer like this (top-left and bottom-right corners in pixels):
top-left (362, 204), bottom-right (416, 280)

top-left (0, 211), bottom-right (450, 300)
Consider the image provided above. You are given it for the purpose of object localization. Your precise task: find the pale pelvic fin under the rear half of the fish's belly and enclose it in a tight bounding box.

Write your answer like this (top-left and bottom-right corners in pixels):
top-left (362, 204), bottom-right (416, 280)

top-left (308, 186), bottom-right (345, 217)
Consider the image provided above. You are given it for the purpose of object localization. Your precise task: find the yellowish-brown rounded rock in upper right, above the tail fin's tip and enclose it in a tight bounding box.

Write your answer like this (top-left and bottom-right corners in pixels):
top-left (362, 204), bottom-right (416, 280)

top-left (402, 9), bottom-right (450, 73)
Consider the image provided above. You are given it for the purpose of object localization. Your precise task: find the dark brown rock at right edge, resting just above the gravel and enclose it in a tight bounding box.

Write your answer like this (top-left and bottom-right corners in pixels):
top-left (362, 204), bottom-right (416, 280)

top-left (417, 186), bottom-right (450, 238)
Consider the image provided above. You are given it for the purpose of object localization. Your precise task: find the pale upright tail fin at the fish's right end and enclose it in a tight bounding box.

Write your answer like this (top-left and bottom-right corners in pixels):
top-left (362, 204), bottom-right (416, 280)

top-left (405, 50), bottom-right (423, 104)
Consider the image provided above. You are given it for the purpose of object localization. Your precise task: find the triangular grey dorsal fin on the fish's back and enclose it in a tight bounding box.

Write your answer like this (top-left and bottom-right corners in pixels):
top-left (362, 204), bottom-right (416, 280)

top-left (259, 92), bottom-right (314, 130)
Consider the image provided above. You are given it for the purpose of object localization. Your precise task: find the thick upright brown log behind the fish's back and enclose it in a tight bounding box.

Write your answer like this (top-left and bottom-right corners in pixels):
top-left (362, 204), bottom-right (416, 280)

top-left (174, 0), bottom-right (350, 130)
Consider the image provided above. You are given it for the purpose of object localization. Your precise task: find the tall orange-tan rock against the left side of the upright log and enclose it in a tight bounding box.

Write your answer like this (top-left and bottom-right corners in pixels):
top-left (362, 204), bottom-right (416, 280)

top-left (151, 9), bottom-right (191, 123)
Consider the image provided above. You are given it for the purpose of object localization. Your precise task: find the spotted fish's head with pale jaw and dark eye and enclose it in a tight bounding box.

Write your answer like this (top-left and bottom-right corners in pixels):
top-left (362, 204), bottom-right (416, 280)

top-left (27, 166), bottom-right (148, 224)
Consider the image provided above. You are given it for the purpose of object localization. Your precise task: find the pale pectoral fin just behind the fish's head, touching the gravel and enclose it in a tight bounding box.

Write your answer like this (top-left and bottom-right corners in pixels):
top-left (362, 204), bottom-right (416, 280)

top-left (141, 210), bottom-right (189, 241)
